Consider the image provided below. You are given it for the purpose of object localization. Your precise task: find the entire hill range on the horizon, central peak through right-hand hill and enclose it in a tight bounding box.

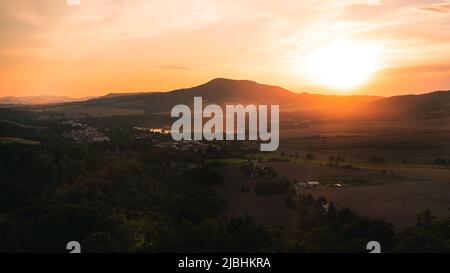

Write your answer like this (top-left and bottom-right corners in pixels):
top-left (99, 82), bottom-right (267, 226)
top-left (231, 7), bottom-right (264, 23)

top-left (12, 78), bottom-right (450, 119)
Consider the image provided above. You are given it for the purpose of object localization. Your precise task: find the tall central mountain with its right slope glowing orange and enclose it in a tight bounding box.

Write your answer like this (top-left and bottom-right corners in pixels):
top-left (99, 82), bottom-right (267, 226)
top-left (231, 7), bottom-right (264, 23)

top-left (74, 78), bottom-right (380, 113)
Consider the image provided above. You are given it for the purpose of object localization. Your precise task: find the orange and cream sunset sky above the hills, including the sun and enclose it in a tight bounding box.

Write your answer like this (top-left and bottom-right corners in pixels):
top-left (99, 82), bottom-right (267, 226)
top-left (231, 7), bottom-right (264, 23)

top-left (0, 0), bottom-right (450, 97)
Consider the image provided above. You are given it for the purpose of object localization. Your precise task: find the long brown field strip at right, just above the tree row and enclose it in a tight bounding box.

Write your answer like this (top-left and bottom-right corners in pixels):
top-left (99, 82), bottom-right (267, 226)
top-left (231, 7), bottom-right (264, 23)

top-left (280, 132), bottom-right (450, 165)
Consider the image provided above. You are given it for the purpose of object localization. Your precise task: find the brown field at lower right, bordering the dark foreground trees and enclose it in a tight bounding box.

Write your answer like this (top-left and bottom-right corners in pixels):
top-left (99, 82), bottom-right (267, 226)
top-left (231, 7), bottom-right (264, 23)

top-left (305, 181), bottom-right (450, 230)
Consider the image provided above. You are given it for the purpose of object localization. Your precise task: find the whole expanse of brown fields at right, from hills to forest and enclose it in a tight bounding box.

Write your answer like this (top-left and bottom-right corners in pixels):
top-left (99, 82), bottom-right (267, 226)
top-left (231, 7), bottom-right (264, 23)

top-left (267, 120), bottom-right (450, 227)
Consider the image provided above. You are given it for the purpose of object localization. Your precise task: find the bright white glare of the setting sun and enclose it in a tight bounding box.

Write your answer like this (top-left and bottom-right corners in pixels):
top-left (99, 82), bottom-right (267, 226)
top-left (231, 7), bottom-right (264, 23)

top-left (302, 41), bottom-right (381, 91)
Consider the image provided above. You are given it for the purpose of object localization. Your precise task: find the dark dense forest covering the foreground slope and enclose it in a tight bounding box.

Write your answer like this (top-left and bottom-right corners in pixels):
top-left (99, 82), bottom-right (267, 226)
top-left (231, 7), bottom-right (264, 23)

top-left (0, 109), bottom-right (450, 252)
